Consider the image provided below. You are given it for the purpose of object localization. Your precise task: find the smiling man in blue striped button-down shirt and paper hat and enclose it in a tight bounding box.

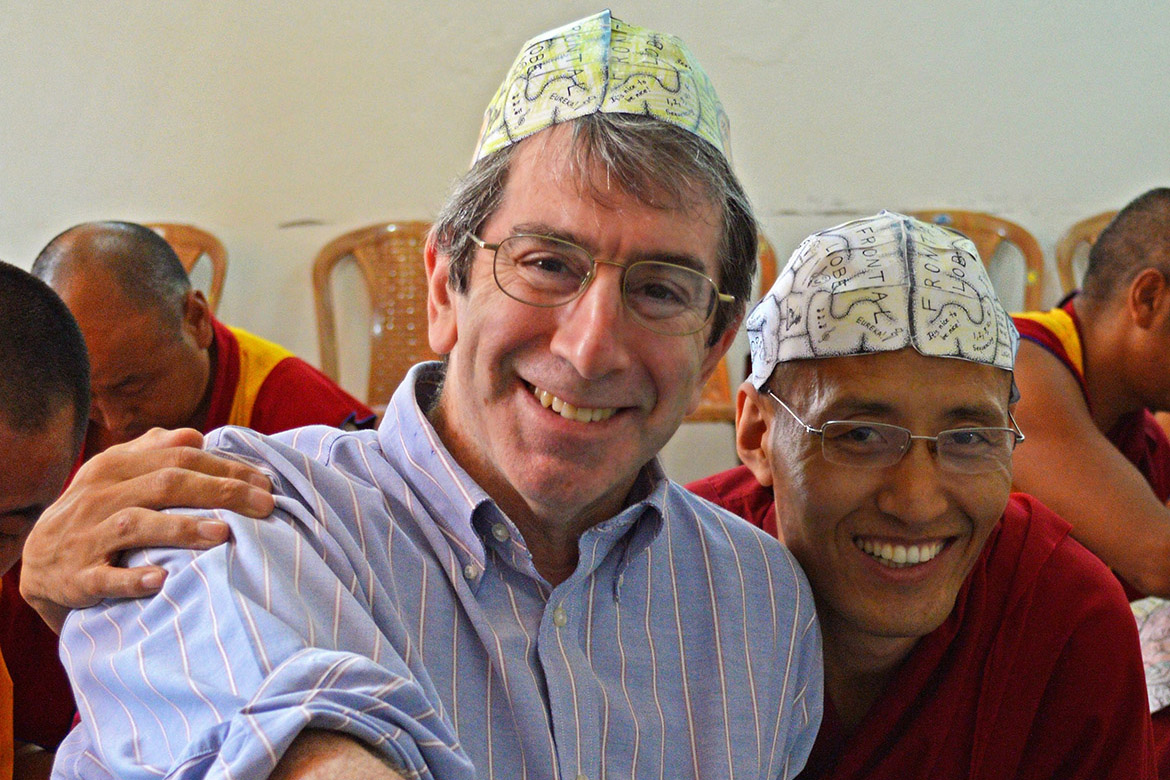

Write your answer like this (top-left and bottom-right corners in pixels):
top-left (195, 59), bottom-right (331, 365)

top-left (34, 12), bottom-right (821, 780)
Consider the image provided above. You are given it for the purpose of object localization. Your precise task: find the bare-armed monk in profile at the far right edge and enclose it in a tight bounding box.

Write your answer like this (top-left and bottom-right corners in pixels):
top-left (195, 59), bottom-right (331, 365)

top-left (1016, 188), bottom-right (1170, 599)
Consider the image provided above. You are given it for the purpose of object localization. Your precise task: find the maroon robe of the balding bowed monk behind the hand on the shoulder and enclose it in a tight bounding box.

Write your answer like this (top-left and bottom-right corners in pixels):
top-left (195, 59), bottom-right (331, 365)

top-left (0, 320), bottom-right (374, 750)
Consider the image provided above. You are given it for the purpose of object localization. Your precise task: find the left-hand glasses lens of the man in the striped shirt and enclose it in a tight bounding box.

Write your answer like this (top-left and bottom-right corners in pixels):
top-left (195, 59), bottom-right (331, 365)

top-left (495, 235), bottom-right (593, 306)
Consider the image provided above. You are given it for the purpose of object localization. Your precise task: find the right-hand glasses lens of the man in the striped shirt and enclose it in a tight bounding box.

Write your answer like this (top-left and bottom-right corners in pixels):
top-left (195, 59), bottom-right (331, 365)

top-left (622, 262), bottom-right (718, 336)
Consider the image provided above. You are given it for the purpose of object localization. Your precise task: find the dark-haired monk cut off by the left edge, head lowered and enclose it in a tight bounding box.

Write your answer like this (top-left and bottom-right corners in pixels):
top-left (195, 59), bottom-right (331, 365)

top-left (0, 262), bottom-right (89, 778)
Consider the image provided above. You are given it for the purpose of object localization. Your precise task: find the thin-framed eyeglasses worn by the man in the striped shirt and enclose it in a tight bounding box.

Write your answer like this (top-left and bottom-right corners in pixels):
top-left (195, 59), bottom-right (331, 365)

top-left (470, 233), bottom-right (735, 336)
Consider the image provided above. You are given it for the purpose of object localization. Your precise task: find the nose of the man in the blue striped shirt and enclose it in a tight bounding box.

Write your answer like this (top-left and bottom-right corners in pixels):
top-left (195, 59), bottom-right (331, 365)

top-left (550, 262), bottom-right (648, 379)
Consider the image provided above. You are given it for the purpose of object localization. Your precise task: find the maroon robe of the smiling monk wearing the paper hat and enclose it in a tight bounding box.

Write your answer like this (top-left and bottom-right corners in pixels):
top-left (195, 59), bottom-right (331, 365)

top-left (688, 467), bottom-right (1156, 780)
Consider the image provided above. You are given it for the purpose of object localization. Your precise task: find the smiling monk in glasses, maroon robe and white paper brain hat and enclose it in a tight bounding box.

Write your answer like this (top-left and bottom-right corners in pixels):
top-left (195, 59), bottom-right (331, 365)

top-left (690, 212), bottom-right (1154, 780)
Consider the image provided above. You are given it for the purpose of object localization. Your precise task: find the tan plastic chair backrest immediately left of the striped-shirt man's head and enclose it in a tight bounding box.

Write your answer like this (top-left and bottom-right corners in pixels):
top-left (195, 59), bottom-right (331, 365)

top-left (312, 222), bottom-right (436, 408)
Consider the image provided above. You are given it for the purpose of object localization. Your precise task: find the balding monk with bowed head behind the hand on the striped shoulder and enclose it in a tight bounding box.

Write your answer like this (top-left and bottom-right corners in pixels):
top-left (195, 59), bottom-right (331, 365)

top-left (0, 222), bottom-right (373, 748)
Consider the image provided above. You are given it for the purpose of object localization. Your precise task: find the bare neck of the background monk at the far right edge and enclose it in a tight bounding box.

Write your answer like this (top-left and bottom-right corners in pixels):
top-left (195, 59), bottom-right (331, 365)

top-left (1073, 298), bottom-right (1142, 434)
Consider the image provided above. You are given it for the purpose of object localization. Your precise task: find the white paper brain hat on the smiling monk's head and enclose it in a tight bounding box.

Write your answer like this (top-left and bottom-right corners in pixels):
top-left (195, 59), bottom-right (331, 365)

top-left (748, 212), bottom-right (1019, 388)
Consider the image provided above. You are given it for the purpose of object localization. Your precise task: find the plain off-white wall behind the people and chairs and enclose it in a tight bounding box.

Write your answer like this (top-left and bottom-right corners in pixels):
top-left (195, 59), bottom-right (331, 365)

top-left (0, 0), bottom-right (1170, 477)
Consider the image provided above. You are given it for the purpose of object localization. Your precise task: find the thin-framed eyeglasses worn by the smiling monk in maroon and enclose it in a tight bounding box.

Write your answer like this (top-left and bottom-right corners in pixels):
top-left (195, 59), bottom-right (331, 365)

top-left (768, 391), bottom-right (1024, 474)
